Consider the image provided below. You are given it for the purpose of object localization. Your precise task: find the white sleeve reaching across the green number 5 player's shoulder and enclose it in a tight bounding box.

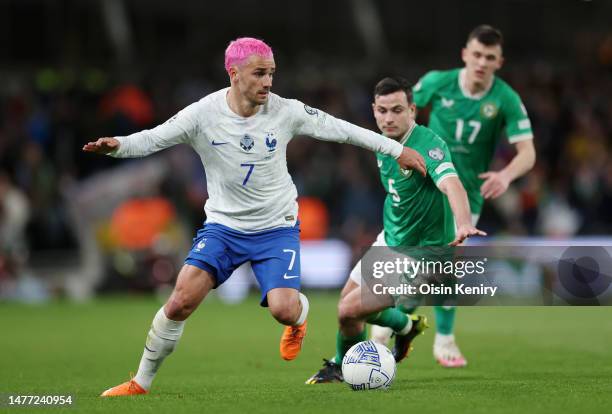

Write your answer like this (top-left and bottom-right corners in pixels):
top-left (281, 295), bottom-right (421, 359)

top-left (289, 99), bottom-right (404, 158)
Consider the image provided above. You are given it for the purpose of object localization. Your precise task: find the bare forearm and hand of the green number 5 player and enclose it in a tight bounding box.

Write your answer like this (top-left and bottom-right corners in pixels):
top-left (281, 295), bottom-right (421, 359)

top-left (438, 176), bottom-right (487, 246)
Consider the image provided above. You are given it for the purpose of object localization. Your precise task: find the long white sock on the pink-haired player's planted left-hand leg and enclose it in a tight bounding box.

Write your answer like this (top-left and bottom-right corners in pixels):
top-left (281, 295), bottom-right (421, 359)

top-left (134, 306), bottom-right (185, 390)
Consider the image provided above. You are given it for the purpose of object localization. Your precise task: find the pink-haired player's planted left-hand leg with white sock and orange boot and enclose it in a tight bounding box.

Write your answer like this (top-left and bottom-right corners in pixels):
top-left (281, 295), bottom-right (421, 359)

top-left (102, 265), bottom-right (215, 397)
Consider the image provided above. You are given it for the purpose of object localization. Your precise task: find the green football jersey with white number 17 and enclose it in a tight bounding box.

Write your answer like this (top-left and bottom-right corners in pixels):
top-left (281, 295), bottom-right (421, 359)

top-left (413, 69), bottom-right (533, 214)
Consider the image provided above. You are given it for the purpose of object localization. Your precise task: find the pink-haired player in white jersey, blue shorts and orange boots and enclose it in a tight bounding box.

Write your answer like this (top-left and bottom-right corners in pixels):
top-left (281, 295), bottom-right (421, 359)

top-left (83, 38), bottom-right (426, 396)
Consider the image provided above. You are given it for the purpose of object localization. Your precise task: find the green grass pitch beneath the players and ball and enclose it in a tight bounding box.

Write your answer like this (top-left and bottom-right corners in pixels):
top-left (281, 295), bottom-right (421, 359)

top-left (0, 293), bottom-right (612, 414)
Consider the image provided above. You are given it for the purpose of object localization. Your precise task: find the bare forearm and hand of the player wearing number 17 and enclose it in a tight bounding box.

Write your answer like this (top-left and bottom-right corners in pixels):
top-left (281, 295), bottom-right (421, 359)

top-left (478, 139), bottom-right (536, 199)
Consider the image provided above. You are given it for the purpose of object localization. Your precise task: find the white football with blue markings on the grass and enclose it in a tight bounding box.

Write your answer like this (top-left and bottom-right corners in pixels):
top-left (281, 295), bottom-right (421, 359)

top-left (342, 341), bottom-right (395, 391)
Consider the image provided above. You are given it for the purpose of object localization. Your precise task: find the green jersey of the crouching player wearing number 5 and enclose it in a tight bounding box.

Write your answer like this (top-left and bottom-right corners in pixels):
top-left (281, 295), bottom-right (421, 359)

top-left (376, 124), bottom-right (457, 246)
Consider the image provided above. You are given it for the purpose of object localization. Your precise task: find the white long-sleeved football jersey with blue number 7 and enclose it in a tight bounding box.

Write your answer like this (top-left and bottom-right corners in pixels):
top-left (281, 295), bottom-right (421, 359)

top-left (109, 88), bottom-right (403, 233)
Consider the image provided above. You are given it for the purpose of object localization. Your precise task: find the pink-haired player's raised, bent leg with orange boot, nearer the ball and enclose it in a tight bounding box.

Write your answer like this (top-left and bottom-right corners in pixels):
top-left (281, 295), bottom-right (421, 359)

top-left (267, 288), bottom-right (309, 361)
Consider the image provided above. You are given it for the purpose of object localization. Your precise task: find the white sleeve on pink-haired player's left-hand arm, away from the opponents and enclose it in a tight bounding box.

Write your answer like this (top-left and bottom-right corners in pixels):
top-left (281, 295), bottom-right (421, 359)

top-left (108, 102), bottom-right (201, 158)
